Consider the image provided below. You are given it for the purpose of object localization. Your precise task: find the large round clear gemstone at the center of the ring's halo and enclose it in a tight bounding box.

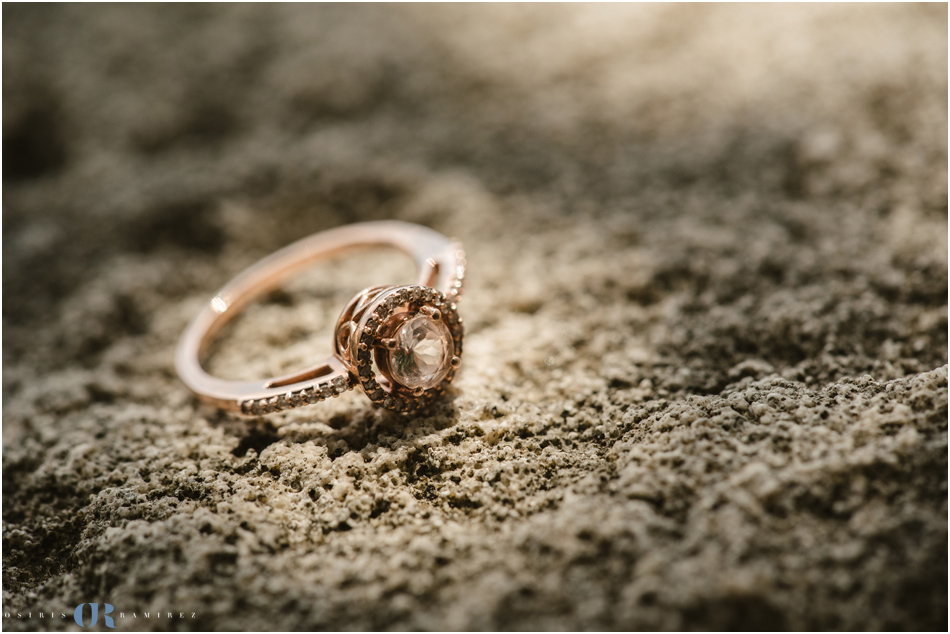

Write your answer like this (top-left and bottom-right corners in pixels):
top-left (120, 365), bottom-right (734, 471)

top-left (390, 315), bottom-right (455, 390)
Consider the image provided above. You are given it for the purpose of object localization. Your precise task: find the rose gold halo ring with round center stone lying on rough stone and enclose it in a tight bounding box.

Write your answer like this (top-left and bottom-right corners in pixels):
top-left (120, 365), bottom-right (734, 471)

top-left (175, 221), bottom-right (465, 415)
